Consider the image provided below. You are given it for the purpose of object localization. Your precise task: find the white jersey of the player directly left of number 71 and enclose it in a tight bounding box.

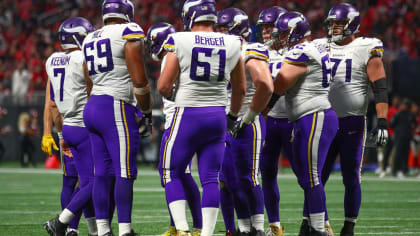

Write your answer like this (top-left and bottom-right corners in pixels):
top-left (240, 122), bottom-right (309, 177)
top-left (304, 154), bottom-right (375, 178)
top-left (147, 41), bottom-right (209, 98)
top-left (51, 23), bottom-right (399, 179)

top-left (283, 42), bottom-right (331, 121)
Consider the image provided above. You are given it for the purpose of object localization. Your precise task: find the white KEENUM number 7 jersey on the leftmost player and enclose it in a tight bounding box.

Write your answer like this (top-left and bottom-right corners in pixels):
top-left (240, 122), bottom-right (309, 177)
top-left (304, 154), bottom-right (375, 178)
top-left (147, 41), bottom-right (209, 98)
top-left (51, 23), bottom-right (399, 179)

top-left (45, 50), bottom-right (88, 127)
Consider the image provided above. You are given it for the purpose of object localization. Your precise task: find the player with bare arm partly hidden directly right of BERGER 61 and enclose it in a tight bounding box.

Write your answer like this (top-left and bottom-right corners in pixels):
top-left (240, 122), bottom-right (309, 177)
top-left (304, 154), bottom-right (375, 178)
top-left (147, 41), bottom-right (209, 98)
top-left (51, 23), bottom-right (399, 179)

top-left (217, 8), bottom-right (273, 235)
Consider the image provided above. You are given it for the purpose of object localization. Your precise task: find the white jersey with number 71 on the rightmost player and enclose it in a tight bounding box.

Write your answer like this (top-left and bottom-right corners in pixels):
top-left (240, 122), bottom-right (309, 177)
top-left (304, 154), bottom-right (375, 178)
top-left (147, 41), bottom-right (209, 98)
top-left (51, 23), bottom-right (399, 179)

top-left (322, 37), bottom-right (384, 117)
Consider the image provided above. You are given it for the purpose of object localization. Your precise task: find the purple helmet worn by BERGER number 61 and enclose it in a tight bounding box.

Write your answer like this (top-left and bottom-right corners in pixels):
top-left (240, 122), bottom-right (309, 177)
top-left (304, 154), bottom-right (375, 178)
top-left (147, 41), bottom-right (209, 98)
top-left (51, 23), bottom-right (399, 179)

top-left (182, 0), bottom-right (217, 31)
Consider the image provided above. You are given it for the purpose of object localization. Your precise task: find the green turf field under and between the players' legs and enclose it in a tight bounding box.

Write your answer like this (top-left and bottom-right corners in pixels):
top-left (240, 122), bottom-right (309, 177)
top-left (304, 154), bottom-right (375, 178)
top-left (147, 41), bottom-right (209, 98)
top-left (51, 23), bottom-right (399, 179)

top-left (0, 168), bottom-right (420, 236)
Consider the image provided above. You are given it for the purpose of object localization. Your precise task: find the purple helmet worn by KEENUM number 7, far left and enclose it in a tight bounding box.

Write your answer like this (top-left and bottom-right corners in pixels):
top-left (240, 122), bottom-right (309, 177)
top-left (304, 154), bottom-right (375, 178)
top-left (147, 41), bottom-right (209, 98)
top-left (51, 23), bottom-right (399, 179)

top-left (58, 17), bottom-right (95, 49)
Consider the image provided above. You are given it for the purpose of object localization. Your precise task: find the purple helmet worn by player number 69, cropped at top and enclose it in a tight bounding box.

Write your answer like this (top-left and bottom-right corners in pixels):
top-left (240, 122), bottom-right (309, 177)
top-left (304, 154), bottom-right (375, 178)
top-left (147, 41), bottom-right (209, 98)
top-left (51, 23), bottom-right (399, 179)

top-left (102, 0), bottom-right (134, 22)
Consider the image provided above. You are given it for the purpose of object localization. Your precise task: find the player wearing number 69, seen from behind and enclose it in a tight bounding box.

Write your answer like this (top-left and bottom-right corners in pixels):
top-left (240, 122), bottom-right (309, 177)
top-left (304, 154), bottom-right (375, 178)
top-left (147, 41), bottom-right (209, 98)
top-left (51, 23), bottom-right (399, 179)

top-left (82, 0), bottom-right (152, 236)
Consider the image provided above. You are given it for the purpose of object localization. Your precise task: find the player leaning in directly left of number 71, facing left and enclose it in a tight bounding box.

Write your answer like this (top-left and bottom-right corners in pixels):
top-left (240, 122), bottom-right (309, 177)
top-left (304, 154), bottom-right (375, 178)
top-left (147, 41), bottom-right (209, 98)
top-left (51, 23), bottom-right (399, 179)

top-left (268, 12), bottom-right (338, 236)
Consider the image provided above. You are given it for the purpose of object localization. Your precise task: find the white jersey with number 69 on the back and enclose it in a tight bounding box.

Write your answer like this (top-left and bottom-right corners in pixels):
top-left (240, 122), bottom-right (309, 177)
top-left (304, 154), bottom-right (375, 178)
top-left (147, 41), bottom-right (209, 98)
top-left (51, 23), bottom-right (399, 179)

top-left (82, 22), bottom-right (144, 106)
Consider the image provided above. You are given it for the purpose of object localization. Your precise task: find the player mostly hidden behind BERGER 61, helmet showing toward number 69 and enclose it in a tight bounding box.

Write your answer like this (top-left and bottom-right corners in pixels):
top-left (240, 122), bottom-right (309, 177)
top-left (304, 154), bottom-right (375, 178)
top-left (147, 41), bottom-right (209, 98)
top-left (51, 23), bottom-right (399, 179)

top-left (147, 23), bottom-right (202, 236)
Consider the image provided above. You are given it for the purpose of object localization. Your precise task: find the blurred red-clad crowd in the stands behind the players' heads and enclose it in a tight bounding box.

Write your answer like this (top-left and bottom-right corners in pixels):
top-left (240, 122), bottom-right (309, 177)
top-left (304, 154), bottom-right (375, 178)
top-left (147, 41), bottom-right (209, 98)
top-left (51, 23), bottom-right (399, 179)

top-left (0, 0), bottom-right (420, 105)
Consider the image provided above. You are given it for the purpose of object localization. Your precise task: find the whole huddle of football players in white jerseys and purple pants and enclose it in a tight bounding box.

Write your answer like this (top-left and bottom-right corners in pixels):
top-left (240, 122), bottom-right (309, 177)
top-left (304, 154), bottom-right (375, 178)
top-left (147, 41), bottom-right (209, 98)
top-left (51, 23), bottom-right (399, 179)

top-left (42, 0), bottom-right (388, 236)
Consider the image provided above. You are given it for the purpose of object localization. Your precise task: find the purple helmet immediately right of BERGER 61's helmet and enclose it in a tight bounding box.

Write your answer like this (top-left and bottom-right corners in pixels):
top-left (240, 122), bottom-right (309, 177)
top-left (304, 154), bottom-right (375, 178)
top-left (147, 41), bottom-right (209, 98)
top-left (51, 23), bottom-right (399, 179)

top-left (217, 7), bottom-right (251, 41)
